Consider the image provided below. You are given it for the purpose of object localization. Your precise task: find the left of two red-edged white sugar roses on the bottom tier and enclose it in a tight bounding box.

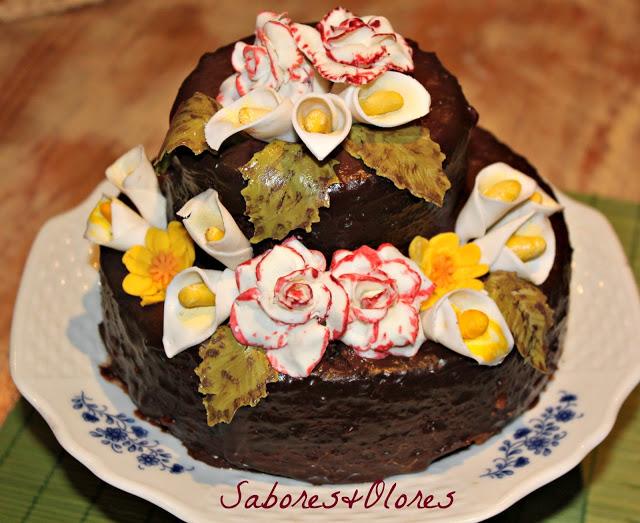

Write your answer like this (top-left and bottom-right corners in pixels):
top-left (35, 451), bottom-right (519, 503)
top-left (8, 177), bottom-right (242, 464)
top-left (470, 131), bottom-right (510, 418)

top-left (229, 238), bottom-right (348, 377)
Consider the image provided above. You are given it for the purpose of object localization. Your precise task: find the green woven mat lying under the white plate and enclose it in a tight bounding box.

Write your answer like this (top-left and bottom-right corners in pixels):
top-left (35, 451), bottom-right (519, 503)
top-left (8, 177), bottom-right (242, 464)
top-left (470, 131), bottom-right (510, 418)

top-left (0, 195), bottom-right (640, 523)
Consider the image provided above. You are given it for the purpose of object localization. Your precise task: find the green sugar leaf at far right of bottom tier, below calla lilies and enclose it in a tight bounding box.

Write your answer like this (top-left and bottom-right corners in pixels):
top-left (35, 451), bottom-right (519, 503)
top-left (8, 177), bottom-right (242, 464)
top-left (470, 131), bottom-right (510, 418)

top-left (485, 271), bottom-right (553, 373)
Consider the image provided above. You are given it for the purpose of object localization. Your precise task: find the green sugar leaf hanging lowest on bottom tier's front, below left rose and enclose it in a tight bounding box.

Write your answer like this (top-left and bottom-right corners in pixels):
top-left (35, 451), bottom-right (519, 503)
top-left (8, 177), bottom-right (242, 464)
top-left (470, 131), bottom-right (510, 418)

top-left (195, 325), bottom-right (278, 427)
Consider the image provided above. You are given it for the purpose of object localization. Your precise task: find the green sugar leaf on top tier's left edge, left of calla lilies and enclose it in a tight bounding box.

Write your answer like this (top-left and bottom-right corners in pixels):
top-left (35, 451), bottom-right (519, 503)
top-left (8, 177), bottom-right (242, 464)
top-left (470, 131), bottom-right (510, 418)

top-left (155, 92), bottom-right (220, 172)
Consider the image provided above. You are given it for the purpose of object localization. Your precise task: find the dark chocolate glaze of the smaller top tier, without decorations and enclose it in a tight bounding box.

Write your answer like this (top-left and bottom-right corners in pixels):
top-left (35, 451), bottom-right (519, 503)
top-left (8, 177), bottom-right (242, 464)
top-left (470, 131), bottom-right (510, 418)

top-left (163, 42), bottom-right (478, 256)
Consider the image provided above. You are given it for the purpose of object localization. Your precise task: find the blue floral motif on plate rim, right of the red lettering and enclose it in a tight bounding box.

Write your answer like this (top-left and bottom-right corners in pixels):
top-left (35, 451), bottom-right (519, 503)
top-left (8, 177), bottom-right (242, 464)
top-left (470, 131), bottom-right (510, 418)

top-left (480, 391), bottom-right (582, 479)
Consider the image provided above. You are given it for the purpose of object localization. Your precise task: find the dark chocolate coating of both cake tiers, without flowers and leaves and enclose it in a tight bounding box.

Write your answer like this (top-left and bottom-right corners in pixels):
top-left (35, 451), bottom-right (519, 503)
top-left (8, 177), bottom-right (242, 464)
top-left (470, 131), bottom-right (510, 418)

top-left (101, 39), bottom-right (571, 483)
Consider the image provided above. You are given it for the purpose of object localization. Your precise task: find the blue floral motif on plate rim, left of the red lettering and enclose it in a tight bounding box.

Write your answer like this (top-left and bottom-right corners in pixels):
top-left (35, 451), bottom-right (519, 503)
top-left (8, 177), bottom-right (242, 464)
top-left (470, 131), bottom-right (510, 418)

top-left (71, 391), bottom-right (193, 474)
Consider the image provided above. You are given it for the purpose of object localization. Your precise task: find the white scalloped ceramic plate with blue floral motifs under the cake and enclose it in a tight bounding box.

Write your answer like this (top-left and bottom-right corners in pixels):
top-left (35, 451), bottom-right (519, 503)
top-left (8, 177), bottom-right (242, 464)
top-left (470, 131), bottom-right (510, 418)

top-left (11, 184), bottom-right (640, 522)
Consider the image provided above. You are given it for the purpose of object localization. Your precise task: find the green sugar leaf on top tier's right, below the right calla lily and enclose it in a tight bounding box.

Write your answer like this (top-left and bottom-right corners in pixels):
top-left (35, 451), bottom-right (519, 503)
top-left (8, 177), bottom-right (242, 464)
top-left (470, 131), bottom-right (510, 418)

top-left (344, 124), bottom-right (451, 207)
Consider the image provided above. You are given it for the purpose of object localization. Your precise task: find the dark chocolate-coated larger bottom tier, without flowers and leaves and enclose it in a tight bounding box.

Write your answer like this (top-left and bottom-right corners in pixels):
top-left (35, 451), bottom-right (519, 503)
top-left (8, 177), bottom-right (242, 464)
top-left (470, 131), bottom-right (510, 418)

top-left (101, 129), bottom-right (571, 484)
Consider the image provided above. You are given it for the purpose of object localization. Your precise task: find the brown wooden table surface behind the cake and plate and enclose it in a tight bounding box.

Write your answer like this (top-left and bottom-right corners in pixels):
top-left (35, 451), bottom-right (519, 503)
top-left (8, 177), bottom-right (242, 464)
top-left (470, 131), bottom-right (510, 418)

top-left (0, 0), bottom-right (640, 422)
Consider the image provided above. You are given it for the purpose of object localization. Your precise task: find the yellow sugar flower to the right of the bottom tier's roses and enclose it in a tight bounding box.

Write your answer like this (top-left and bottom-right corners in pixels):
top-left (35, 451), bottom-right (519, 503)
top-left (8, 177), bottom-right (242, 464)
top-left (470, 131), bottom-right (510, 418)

top-left (409, 232), bottom-right (489, 309)
